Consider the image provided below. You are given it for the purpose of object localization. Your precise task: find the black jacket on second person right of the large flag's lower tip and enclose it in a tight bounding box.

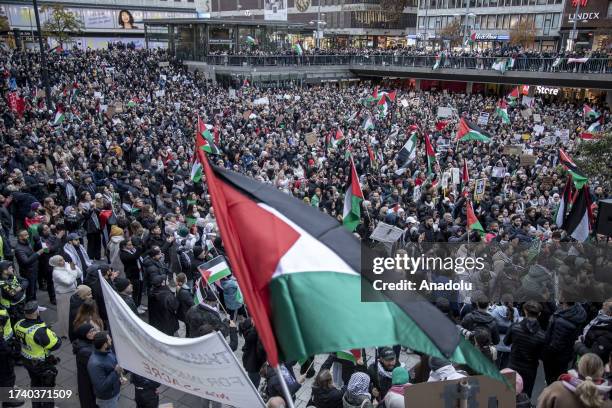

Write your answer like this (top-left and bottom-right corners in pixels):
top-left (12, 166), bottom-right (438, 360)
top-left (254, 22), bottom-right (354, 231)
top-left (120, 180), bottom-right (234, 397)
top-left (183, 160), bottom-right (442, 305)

top-left (544, 303), bottom-right (586, 361)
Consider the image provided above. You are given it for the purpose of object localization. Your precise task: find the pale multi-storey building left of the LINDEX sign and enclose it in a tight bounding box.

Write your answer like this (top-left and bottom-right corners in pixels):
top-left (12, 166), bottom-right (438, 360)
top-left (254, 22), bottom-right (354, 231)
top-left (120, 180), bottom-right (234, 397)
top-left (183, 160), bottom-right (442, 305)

top-left (417, 0), bottom-right (564, 51)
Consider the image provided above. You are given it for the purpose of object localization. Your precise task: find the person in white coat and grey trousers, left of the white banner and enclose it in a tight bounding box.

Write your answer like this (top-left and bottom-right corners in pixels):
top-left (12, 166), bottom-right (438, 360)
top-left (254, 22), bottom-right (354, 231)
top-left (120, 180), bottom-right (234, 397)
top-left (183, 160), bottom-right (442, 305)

top-left (49, 255), bottom-right (83, 338)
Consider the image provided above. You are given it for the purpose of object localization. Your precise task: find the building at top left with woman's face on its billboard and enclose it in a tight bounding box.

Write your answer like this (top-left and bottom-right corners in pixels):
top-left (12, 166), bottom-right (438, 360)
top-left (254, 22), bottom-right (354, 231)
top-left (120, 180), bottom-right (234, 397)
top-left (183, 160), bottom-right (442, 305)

top-left (0, 0), bottom-right (196, 48)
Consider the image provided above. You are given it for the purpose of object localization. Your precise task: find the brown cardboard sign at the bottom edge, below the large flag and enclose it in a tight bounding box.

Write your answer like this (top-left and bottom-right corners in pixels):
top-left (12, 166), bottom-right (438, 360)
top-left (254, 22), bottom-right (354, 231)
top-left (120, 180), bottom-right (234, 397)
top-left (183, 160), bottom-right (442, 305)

top-left (404, 373), bottom-right (516, 408)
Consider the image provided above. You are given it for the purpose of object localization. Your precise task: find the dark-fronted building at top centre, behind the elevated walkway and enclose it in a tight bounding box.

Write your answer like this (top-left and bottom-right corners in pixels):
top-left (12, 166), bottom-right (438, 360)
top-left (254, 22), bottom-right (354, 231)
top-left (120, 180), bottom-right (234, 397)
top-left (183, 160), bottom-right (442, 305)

top-left (208, 0), bottom-right (418, 47)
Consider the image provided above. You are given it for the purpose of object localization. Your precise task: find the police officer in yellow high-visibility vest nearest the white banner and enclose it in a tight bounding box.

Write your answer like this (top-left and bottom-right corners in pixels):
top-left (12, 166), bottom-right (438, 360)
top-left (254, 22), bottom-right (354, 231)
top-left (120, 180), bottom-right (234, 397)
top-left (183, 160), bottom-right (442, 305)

top-left (14, 300), bottom-right (62, 408)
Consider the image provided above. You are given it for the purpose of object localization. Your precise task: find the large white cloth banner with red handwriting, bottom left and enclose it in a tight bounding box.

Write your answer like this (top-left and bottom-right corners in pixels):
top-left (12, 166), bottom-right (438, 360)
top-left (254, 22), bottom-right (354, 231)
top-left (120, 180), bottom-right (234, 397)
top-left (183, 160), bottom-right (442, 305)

top-left (99, 273), bottom-right (264, 408)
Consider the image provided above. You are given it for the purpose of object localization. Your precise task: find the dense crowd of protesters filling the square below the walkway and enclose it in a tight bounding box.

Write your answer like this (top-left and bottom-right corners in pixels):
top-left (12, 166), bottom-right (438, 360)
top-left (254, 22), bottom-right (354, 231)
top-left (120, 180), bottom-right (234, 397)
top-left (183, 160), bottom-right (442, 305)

top-left (0, 48), bottom-right (612, 408)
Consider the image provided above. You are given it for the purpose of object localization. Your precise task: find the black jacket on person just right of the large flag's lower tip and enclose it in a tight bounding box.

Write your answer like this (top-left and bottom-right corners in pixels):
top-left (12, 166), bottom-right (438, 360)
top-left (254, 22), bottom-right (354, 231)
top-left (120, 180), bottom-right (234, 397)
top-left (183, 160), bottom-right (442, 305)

top-left (504, 318), bottom-right (546, 371)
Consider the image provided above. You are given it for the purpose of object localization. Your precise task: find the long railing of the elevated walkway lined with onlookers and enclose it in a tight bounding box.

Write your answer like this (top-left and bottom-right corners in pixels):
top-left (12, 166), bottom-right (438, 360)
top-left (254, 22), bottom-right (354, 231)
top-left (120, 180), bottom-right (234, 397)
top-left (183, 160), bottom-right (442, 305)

top-left (189, 55), bottom-right (612, 74)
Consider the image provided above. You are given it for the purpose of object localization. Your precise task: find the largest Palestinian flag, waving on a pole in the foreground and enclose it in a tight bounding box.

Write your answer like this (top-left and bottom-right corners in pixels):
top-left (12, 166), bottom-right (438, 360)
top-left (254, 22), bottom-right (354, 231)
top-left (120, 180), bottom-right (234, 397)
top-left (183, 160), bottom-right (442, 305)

top-left (197, 150), bottom-right (503, 381)
